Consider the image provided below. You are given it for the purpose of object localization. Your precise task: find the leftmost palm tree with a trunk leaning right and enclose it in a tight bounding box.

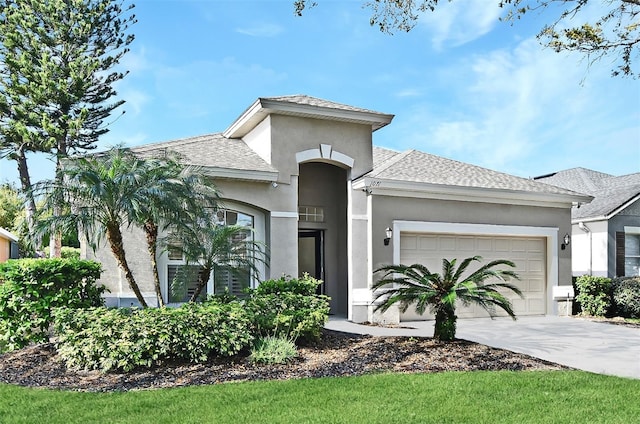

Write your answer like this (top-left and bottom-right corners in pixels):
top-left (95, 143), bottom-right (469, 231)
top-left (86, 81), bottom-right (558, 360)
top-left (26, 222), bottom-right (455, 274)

top-left (37, 148), bottom-right (184, 307)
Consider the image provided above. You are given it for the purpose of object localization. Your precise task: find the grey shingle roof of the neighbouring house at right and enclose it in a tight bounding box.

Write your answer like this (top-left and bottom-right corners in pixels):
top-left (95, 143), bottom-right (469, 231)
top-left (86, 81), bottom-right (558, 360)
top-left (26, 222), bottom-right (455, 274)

top-left (536, 168), bottom-right (640, 220)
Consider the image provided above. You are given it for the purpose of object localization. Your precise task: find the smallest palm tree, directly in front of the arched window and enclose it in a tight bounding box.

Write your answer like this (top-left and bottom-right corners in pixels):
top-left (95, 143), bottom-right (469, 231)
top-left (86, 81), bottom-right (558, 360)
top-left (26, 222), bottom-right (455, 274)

top-left (167, 209), bottom-right (266, 302)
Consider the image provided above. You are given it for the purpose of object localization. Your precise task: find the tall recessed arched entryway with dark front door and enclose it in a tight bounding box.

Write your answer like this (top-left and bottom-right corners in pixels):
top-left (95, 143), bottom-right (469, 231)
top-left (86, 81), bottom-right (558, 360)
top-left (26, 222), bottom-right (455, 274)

top-left (298, 162), bottom-right (348, 316)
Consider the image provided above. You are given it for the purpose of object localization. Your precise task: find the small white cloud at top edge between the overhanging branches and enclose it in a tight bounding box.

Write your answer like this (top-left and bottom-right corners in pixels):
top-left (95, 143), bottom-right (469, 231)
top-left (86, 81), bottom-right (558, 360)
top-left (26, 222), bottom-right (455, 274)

top-left (420, 0), bottom-right (504, 50)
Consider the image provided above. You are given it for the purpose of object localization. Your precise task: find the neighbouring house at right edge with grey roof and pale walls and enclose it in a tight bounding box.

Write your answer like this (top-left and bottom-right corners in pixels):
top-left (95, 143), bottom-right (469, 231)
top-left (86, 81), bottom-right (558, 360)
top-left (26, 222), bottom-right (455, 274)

top-left (535, 168), bottom-right (640, 278)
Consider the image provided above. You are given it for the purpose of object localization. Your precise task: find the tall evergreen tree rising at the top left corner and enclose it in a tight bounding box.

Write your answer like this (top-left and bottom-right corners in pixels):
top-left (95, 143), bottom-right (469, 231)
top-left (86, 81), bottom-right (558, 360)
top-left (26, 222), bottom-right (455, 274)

top-left (0, 0), bottom-right (135, 254)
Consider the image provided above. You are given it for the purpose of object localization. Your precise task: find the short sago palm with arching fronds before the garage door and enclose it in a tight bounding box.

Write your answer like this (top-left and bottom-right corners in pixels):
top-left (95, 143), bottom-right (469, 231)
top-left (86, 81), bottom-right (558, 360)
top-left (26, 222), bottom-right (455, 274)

top-left (373, 256), bottom-right (522, 341)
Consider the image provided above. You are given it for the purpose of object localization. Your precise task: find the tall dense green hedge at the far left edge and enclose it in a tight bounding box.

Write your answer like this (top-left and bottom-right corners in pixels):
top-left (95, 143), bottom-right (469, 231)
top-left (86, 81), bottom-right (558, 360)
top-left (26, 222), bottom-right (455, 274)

top-left (0, 259), bottom-right (105, 350)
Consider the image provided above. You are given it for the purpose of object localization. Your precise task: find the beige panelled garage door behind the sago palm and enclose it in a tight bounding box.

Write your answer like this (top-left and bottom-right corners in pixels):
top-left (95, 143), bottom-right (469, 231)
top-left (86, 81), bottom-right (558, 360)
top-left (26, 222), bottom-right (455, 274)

top-left (400, 233), bottom-right (546, 321)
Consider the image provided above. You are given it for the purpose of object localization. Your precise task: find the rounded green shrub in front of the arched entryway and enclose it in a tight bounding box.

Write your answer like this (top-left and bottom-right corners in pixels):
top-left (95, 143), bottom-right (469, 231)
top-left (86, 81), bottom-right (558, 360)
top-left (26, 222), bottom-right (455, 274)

top-left (246, 275), bottom-right (329, 340)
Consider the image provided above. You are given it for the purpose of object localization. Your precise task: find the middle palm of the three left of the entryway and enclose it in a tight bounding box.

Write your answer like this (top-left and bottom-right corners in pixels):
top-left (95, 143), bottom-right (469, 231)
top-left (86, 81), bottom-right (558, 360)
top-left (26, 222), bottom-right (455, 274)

top-left (127, 156), bottom-right (219, 307)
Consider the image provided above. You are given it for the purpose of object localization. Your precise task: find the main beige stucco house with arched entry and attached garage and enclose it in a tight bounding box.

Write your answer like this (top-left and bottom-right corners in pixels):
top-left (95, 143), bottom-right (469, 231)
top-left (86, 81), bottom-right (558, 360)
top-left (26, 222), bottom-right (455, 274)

top-left (87, 95), bottom-right (591, 322)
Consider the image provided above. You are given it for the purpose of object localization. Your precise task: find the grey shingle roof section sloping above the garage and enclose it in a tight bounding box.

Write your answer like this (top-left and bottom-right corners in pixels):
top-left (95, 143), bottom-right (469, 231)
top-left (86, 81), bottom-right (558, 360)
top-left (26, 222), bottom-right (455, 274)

top-left (367, 147), bottom-right (579, 195)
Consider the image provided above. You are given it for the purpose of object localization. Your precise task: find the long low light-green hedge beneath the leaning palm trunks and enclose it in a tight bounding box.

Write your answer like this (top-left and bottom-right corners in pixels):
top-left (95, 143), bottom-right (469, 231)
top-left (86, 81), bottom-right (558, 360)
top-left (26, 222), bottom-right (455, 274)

top-left (54, 302), bottom-right (253, 372)
